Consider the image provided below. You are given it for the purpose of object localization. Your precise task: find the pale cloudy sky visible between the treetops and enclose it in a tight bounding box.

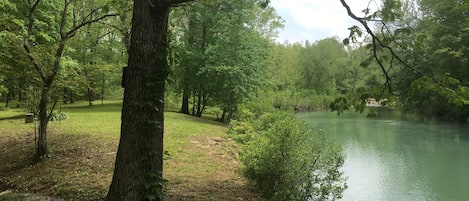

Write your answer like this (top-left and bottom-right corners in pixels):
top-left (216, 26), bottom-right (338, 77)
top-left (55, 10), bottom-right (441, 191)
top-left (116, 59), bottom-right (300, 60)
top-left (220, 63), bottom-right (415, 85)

top-left (271, 0), bottom-right (376, 43)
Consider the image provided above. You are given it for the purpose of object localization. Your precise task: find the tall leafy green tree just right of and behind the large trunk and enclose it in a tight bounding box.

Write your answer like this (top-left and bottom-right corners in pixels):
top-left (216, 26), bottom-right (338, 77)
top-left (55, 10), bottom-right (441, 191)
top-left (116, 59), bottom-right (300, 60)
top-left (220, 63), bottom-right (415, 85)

top-left (172, 0), bottom-right (281, 119)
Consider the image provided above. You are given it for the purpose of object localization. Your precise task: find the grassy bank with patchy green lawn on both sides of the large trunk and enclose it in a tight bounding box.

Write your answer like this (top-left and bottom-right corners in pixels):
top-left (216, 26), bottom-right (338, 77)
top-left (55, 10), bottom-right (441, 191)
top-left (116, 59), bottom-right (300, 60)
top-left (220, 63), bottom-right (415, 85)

top-left (0, 101), bottom-right (258, 200)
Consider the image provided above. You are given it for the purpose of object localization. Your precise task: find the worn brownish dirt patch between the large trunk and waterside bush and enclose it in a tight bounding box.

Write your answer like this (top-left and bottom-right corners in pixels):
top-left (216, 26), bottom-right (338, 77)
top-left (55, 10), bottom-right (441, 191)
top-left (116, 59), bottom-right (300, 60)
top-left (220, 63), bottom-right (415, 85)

top-left (165, 136), bottom-right (260, 201)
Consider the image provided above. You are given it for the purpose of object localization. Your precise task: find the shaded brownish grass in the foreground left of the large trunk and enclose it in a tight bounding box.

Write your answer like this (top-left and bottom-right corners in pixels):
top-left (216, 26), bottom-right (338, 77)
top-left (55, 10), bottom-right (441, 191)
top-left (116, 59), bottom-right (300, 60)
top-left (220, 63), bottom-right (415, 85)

top-left (0, 132), bottom-right (115, 201)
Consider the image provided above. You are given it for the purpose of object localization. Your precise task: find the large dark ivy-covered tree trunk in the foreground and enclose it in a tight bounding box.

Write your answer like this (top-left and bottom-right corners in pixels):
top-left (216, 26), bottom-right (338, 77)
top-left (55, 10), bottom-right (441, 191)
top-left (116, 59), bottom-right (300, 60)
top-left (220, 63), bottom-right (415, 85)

top-left (106, 1), bottom-right (170, 201)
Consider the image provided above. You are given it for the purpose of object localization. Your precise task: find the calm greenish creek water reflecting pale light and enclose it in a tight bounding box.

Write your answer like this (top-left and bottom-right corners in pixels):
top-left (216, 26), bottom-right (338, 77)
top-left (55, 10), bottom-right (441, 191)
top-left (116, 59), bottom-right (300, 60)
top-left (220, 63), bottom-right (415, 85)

top-left (298, 111), bottom-right (469, 201)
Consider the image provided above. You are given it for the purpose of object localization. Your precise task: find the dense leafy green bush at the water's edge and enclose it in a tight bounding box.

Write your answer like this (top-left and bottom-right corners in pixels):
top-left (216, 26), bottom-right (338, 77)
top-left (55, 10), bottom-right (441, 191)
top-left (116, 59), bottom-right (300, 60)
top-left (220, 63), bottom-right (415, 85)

top-left (229, 104), bottom-right (346, 200)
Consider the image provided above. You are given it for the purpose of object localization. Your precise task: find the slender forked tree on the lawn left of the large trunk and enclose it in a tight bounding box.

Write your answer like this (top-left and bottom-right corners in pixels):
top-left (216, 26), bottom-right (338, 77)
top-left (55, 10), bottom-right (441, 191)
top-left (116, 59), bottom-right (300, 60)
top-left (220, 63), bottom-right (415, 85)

top-left (17, 0), bottom-right (114, 159)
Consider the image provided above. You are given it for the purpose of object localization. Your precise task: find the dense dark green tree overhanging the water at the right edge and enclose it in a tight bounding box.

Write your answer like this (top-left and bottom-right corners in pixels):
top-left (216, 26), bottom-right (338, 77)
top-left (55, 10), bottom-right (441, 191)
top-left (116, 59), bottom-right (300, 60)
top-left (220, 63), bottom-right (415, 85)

top-left (396, 0), bottom-right (469, 121)
